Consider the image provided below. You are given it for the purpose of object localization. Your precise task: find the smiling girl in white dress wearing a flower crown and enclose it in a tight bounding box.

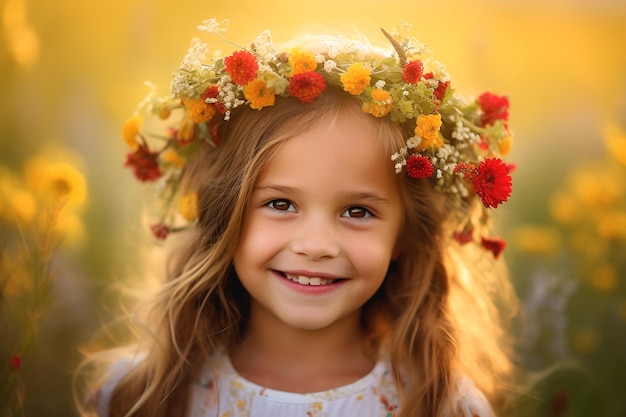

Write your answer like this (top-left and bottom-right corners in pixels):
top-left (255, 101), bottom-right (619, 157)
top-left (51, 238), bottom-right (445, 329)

top-left (81, 20), bottom-right (514, 417)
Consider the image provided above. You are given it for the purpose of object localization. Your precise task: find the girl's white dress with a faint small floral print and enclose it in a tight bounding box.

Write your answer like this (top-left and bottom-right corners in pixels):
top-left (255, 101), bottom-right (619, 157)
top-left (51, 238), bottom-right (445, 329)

top-left (98, 353), bottom-right (494, 417)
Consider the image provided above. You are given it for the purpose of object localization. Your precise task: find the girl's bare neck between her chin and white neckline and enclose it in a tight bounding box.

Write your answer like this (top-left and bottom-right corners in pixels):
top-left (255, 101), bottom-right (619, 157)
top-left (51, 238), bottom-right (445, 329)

top-left (231, 300), bottom-right (376, 392)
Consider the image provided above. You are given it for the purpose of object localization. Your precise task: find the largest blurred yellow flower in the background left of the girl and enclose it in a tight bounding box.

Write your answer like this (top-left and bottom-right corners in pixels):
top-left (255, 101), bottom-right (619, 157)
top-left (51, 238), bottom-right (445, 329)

top-left (24, 156), bottom-right (87, 205)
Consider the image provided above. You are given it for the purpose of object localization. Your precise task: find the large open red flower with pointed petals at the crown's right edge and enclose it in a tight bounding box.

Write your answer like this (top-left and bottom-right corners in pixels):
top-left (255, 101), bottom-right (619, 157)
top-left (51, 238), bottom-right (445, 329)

top-left (466, 158), bottom-right (511, 208)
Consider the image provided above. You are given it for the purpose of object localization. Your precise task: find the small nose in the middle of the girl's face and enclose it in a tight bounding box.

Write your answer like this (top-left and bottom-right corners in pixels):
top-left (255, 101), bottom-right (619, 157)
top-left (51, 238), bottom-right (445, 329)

top-left (291, 214), bottom-right (341, 260)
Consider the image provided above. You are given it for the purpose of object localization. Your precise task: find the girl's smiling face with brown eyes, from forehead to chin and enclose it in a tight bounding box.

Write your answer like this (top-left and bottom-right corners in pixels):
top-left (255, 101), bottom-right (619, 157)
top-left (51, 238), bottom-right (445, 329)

top-left (234, 108), bottom-right (403, 330)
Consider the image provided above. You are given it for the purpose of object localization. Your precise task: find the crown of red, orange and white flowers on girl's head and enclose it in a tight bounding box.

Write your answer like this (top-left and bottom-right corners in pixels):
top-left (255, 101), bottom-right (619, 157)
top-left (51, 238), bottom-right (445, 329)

top-left (122, 19), bottom-right (512, 257)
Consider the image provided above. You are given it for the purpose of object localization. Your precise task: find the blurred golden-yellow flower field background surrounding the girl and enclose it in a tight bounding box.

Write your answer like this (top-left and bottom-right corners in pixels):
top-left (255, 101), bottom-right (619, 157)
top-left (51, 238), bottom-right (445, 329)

top-left (0, 0), bottom-right (626, 417)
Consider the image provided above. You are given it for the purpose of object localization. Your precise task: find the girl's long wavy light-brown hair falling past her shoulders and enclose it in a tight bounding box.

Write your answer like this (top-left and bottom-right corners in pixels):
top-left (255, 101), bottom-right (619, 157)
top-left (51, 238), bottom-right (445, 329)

top-left (75, 88), bottom-right (514, 417)
